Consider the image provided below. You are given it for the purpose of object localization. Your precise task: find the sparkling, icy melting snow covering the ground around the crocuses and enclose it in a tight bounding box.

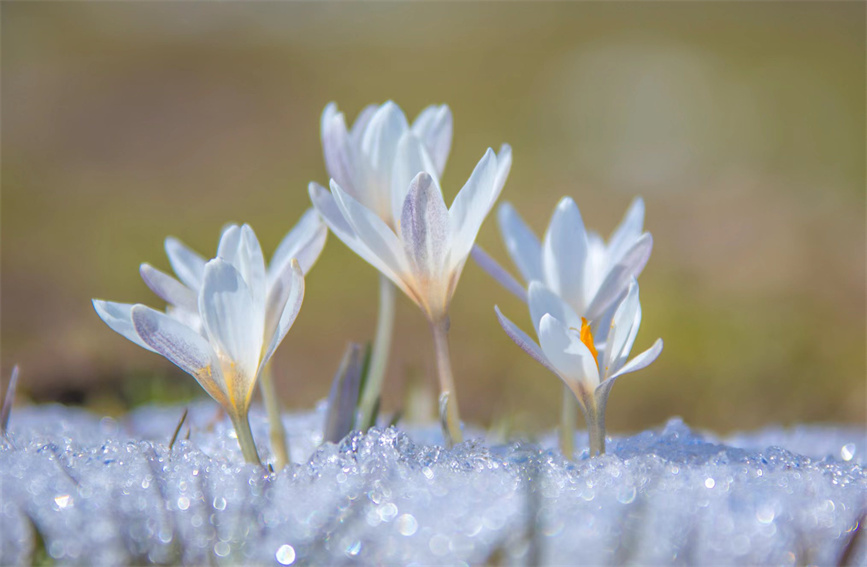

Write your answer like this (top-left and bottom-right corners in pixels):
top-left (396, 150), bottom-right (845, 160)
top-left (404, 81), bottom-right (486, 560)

top-left (0, 403), bottom-right (867, 565)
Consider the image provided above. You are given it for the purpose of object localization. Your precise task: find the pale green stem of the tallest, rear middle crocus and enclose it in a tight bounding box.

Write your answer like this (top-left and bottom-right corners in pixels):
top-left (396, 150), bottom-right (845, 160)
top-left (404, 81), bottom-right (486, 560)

top-left (358, 274), bottom-right (395, 429)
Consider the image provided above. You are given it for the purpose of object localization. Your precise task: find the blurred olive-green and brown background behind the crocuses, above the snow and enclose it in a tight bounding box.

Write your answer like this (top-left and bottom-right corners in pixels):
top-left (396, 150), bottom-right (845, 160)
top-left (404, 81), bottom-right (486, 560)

top-left (0, 2), bottom-right (867, 432)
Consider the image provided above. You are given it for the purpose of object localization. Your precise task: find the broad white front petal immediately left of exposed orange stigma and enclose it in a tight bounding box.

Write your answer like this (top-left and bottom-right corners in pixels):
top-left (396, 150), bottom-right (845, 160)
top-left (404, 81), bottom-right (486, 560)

top-left (539, 314), bottom-right (599, 395)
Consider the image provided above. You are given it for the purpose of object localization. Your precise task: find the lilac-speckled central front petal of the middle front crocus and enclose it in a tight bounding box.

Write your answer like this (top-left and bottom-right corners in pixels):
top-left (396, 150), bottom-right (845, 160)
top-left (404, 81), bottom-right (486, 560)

top-left (400, 172), bottom-right (450, 281)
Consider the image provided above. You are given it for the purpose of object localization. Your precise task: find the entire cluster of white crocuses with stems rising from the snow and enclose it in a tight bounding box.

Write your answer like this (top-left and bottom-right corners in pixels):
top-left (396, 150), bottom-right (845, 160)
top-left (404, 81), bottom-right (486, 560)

top-left (93, 96), bottom-right (662, 465)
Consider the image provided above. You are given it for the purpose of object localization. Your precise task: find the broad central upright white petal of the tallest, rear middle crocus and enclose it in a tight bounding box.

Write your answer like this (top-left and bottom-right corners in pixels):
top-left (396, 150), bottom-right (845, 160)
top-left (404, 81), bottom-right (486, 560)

top-left (361, 101), bottom-right (409, 210)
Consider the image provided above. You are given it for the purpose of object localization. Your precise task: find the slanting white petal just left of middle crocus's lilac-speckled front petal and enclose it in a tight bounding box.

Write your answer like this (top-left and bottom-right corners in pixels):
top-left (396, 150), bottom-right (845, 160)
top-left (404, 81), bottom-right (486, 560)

top-left (331, 180), bottom-right (409, 276)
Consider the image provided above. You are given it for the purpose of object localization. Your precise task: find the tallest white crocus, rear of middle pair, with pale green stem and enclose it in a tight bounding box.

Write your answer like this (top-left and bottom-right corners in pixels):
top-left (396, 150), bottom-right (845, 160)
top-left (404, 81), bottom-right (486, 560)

top-left (321, 101), bottom-right (452, 428)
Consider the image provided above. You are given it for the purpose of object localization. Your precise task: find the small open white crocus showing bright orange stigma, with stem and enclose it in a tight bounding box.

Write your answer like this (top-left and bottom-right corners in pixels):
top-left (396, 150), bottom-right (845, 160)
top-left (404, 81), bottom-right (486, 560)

top-left (495, 278), bottom-right (662, 456)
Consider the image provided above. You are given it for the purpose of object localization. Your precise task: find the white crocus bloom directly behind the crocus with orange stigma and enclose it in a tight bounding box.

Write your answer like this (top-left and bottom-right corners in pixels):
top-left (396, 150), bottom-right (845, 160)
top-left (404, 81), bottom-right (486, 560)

top-left (498, 197), bottom-right (653, 322)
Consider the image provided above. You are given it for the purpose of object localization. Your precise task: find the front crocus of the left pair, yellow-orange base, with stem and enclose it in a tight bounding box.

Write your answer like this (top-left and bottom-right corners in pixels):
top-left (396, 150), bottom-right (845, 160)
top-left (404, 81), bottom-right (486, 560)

top-left (93, 225), bottom-right (304, 463)
